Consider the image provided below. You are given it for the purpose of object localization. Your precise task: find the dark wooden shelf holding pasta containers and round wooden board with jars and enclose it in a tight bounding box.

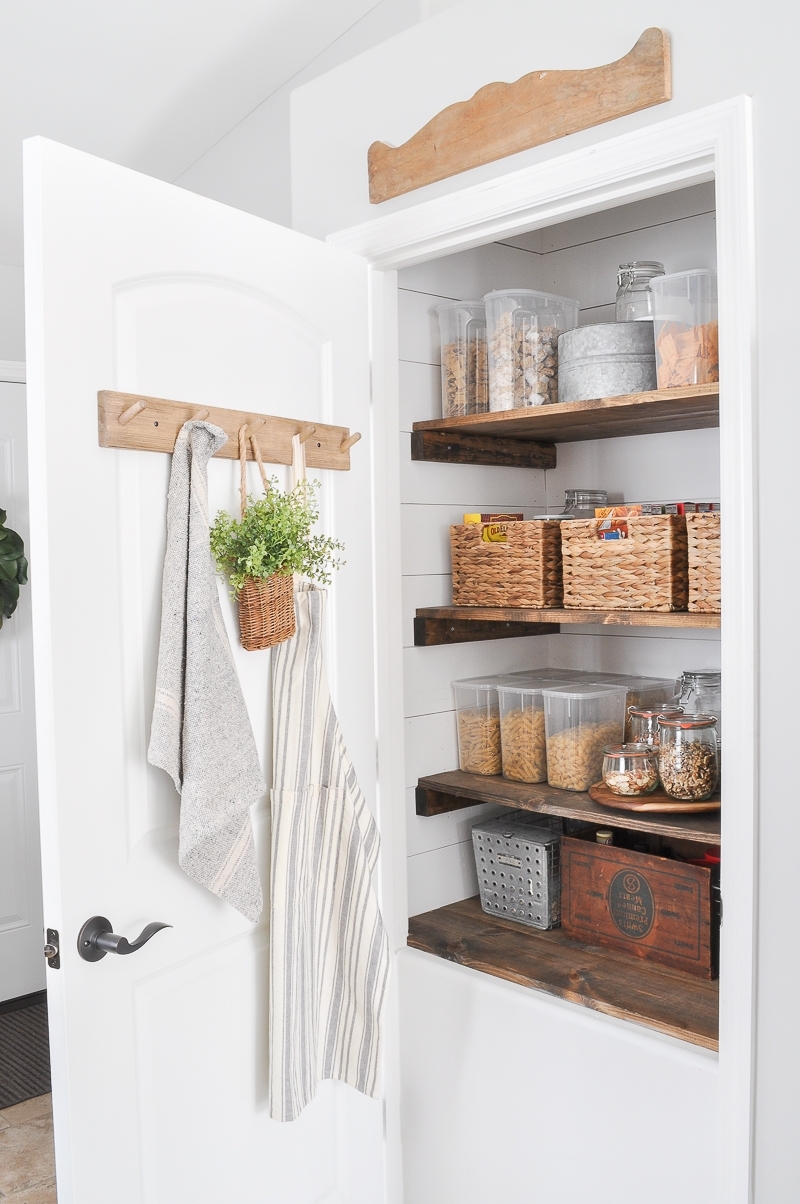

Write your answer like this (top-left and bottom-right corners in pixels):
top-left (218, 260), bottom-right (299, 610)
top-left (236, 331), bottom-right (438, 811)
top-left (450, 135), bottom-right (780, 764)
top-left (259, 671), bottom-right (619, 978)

top-left (417, 769), bottom-right (720, 845)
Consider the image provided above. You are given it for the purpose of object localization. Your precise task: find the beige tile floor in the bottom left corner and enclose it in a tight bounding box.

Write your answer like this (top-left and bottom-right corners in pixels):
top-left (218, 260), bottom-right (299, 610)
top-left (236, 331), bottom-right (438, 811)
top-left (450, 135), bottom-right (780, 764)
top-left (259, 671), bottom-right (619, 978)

top-left (0, 1096), bottom-right (55, 1204)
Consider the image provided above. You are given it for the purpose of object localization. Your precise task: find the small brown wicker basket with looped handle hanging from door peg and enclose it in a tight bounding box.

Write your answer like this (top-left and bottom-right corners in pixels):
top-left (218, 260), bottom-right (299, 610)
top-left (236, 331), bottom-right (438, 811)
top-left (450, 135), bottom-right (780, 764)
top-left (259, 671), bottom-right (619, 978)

top-left (239, 426), bottom-right (296, 653)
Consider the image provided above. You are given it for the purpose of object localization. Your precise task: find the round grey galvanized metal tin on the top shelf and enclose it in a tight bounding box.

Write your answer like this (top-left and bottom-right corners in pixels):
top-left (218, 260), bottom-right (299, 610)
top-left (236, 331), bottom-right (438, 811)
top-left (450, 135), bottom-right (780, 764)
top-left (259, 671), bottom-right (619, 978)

top-left (558, 321), bottom-right (655, 401)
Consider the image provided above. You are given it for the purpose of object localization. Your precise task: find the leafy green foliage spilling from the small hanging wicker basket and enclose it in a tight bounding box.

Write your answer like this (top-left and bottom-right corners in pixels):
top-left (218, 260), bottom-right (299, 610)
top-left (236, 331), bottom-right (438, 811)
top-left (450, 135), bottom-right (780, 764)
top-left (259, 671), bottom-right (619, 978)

top-left (211, 477), bottom-right (345, 596)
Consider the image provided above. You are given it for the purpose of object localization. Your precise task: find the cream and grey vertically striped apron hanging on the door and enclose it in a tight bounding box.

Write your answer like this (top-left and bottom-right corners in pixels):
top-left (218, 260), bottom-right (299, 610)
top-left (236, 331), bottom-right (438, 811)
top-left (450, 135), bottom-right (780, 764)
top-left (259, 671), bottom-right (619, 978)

top-left (270, 583), bottom-right (389, 1121)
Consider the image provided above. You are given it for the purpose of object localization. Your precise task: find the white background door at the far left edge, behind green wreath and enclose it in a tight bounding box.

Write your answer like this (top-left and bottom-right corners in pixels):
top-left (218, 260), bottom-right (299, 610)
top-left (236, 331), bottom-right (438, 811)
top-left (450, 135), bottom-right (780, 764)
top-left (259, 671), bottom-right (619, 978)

top-left (0, 382), bottom-right (45, 999)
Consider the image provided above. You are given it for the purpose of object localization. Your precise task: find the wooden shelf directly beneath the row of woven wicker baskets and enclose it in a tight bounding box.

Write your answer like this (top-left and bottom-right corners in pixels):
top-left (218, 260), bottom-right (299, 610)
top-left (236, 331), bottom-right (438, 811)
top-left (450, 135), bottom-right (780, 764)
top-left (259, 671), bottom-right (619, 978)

top-left (414, 606), bottom-right (722, 648)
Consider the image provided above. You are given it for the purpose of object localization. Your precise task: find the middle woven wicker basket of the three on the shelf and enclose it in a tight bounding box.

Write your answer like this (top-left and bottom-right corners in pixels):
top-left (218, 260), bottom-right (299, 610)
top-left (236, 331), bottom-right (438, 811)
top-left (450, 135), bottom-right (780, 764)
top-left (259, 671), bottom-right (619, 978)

top-left (561, 514), bottom-right (688, 610)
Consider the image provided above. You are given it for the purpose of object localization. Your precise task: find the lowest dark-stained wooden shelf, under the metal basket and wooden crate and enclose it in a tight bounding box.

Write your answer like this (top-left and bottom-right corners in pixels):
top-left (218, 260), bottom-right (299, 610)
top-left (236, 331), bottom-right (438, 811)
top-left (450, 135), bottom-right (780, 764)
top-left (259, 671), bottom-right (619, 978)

top-left (408, 898), bottom-right (719, 1050)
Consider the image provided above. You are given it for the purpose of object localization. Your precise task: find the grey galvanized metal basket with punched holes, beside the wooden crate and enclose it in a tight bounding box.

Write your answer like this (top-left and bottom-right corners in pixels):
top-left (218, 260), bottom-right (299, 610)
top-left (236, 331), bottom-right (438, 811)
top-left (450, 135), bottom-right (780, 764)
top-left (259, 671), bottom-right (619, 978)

top-left (472, 814), bottom-right (561, 928)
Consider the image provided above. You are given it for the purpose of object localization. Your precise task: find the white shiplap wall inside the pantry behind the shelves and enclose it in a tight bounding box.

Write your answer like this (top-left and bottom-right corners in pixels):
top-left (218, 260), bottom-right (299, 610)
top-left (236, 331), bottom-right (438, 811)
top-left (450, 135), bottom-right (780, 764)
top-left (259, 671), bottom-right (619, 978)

top-left (399, 184), bottom-right (719, 915)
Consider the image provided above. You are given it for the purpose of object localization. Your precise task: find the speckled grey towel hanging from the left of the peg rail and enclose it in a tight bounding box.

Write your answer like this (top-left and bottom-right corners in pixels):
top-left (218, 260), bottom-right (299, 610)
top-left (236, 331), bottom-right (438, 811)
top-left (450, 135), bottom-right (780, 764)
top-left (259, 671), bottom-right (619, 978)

top-left (147, 421), bottom-right (266, 921)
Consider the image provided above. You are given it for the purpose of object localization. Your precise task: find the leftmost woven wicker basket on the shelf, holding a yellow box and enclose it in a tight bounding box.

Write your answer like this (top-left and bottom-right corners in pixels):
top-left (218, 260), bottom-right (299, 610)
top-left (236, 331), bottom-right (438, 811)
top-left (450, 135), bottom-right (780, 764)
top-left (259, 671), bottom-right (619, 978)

top-left (451, 521), bottom-right (561, 608)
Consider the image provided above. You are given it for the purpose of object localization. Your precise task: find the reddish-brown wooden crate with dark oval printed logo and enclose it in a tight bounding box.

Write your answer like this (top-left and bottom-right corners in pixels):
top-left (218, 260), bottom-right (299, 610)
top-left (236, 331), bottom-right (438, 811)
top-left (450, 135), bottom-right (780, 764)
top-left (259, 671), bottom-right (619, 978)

top-left (561, 831), bottom-right (719, 979)
